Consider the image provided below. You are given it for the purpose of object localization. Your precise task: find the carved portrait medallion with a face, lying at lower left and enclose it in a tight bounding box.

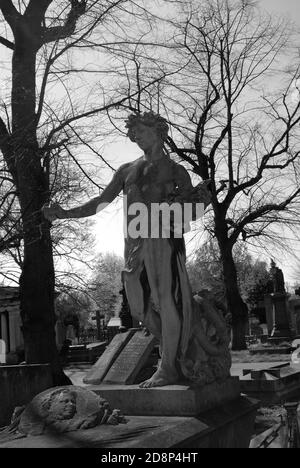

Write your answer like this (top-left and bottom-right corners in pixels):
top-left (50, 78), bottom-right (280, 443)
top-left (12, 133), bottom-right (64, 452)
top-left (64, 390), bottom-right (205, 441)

top-left (0, 386), bottom-right (126, 442)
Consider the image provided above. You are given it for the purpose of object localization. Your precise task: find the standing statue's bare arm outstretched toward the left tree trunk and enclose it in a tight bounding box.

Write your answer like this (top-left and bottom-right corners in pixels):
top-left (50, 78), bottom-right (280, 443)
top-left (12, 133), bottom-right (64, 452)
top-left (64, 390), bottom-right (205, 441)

top-left (43, 165), bottom-right (126, 221)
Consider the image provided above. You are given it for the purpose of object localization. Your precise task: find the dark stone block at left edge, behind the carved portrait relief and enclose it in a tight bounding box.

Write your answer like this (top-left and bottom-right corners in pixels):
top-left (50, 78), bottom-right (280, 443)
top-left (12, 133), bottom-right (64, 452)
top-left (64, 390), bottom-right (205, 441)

top-left (0, 364), bottom-right (53, 427)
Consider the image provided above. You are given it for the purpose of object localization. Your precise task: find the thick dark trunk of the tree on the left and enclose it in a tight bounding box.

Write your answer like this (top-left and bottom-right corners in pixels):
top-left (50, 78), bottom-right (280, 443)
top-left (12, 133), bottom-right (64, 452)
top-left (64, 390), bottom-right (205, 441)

top-left (12, 37), bottom-right (71, 385)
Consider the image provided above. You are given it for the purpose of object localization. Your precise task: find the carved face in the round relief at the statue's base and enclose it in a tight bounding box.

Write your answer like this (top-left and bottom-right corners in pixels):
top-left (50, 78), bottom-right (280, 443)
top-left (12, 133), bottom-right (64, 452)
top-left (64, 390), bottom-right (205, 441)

top-left (42, 390), bottom-right (76, 422)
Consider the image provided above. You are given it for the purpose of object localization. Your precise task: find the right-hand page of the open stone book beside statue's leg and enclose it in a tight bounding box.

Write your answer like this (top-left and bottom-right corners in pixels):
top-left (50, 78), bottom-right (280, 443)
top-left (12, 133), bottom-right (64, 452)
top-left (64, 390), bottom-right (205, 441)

top-left (104, 331), bottom-right (157, 385)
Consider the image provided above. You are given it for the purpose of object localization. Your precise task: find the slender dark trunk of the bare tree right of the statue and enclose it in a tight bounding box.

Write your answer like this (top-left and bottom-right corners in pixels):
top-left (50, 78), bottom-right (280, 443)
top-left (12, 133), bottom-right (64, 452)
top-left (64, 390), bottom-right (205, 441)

top-left (216, 214), bottom-right (248, 351)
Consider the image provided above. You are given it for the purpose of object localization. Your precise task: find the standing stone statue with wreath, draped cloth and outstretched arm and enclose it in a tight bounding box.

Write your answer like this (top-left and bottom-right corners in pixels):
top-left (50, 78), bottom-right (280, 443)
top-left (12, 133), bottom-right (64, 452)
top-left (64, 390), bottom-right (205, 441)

top-left (43, 112), bottom-right (231, 388)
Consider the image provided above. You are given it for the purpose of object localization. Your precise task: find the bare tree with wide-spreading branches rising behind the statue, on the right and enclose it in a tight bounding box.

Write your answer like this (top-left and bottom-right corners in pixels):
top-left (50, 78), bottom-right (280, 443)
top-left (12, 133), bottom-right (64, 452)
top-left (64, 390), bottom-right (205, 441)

top-left (119, 0), bottom-right (300, 350)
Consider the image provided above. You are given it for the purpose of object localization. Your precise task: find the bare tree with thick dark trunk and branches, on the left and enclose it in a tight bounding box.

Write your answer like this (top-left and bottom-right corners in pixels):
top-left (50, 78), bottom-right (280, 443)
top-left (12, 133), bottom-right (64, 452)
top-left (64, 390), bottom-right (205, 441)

top-left (0, 0), bottom-right (164, 384)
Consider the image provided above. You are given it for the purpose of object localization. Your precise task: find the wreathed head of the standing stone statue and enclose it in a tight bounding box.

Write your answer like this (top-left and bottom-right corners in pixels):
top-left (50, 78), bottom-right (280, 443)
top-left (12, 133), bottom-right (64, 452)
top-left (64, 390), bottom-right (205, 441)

top-left (126, 112), bottom-right (169, 151)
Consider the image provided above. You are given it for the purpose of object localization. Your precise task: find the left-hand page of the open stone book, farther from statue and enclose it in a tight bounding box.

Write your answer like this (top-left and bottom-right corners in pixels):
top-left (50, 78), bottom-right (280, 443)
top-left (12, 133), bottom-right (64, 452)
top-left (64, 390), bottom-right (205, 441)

top-left (83, 330), bottom-right (135, 385)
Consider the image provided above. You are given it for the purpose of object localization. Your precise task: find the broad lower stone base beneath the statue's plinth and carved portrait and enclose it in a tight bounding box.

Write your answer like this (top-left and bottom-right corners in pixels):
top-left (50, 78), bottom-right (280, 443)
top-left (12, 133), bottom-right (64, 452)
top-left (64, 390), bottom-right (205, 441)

top-left (1, 397), bottom-right (258, 449)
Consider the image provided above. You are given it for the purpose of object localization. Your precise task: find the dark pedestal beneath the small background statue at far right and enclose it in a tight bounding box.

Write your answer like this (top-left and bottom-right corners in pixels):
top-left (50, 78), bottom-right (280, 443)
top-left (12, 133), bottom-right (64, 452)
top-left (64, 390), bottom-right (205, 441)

top-left (270, 293), bottom-right (291, 344)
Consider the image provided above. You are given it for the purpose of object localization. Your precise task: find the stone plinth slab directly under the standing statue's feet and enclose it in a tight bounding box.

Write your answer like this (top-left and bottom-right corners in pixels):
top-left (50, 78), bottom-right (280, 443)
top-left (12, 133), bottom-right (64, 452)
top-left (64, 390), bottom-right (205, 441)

top-left (88, 377), bottom-right (240, 416)
